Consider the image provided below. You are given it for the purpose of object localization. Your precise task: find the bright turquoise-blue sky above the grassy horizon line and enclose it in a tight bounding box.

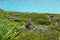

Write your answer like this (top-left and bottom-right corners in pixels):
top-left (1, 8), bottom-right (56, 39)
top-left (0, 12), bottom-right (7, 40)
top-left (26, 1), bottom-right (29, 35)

top-left (0, 0), bottom-right (60, 13)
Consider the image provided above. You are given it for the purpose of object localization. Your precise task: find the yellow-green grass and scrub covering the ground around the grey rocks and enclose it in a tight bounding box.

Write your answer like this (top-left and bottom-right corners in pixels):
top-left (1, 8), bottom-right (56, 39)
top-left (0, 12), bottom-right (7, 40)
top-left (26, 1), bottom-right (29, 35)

top-left (0, 8), bottom-right (60, 40)
